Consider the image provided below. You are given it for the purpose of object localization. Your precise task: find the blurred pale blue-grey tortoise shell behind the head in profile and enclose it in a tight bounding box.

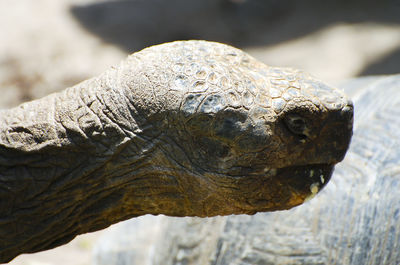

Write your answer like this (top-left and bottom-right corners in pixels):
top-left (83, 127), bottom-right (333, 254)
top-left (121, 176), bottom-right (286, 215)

top-left (94, 75), bottom-right (400, 265)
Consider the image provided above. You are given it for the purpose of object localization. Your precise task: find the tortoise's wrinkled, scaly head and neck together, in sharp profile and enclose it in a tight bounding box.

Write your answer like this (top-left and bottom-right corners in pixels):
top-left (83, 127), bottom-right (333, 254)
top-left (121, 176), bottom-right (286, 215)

top-left (0, 41), bottom-right (353, 262)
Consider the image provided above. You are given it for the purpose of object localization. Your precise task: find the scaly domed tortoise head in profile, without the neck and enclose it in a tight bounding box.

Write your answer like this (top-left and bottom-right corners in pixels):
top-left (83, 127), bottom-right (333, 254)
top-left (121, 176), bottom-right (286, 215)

top-left (125, 41), bottom-right (353, 216)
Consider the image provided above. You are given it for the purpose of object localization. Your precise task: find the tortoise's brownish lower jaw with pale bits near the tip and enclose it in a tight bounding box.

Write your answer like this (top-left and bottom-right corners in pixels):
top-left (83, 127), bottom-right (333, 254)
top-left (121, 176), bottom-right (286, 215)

top-left (203, 164), bottom-right (334, 216)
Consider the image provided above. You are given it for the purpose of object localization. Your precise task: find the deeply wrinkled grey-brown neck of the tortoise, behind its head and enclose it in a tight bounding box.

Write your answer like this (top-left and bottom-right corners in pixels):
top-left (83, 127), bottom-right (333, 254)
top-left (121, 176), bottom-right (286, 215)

top-left (0, 73), bottom-right (175, 261)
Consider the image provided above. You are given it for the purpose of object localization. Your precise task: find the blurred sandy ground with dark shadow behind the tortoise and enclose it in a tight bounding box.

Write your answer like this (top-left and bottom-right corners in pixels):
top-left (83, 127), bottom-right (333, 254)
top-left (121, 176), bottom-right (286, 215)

top-left (0, 0), bottom-right (400, 265)
